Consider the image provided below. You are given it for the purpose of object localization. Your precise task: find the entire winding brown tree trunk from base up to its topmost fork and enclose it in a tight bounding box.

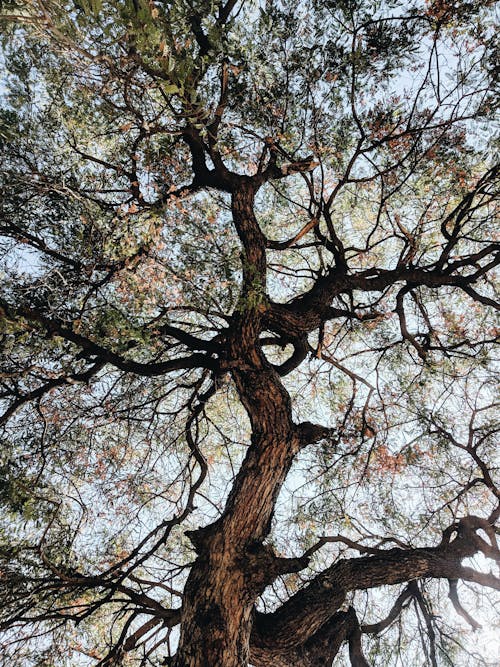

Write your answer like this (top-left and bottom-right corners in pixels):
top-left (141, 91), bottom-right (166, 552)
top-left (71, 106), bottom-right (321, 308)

top-left (174, 187), bottom-right (303, 667)
